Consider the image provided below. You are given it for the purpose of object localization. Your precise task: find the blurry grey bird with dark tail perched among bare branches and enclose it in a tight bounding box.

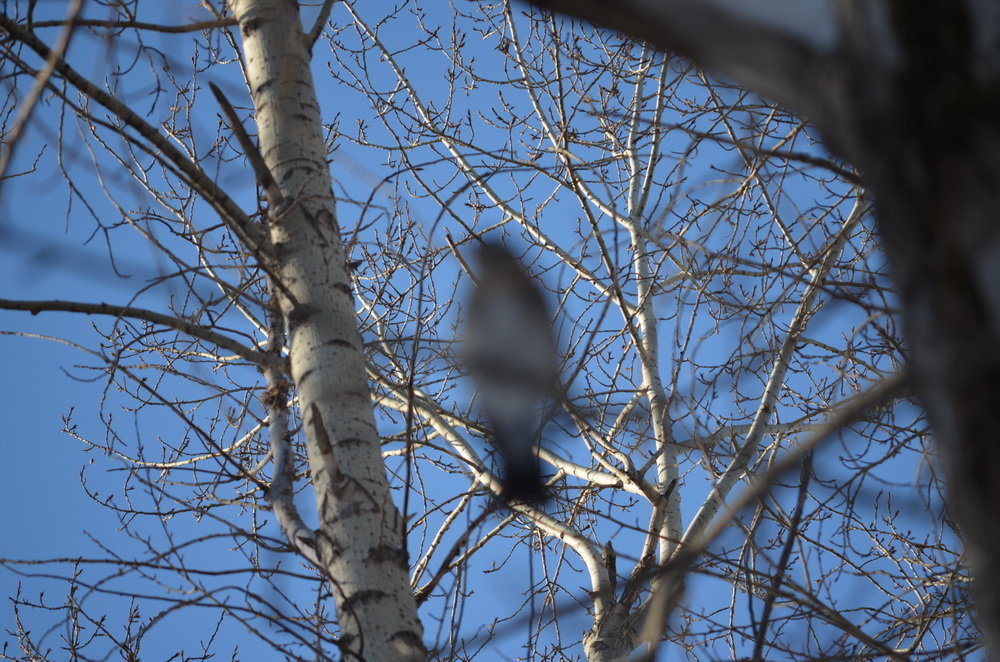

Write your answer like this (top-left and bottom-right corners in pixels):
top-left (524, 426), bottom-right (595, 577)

top-left (465, 242), bottom-right (559, 503)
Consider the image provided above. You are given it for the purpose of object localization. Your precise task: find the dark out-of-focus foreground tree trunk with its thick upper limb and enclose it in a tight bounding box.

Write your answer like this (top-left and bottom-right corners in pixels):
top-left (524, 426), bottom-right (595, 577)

top-left (536, 0), bottom-right (1000, 654)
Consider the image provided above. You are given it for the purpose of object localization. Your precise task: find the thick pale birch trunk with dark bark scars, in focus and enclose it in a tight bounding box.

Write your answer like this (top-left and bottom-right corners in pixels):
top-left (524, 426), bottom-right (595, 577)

top-left (230, 0), bottom-right (427, 661)
